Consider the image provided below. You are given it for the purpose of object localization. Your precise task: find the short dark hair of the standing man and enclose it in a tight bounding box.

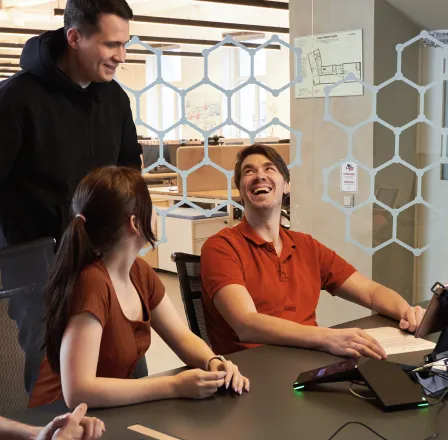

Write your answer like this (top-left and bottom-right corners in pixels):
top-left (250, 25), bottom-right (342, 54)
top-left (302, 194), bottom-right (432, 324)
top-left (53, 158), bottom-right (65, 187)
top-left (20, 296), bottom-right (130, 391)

top-left (64, 0), bottom-right (134, 36)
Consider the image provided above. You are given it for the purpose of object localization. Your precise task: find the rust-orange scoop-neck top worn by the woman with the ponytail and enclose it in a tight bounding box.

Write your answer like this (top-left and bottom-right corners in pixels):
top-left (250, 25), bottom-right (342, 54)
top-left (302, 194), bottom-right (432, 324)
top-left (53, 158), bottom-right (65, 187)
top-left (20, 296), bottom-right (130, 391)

top-left (29, 258), bottom-right (165, 407)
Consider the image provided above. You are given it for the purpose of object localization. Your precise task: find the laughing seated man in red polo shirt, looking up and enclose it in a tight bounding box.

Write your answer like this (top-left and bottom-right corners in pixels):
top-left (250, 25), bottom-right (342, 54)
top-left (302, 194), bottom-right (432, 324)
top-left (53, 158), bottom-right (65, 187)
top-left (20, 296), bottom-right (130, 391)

top-left (201, 145), bottom-right (425, 359)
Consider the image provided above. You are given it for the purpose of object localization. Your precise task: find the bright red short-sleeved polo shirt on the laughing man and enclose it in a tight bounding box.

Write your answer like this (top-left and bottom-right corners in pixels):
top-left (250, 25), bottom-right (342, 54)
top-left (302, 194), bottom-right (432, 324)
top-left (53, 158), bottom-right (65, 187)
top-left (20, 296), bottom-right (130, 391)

top-left (201, 217), bottom-right (356, 354)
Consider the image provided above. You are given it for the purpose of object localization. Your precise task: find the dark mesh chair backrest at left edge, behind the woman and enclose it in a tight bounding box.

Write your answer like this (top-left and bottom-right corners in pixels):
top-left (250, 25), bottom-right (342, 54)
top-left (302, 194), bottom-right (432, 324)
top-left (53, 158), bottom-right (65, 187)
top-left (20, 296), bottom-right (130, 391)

top-left (0, 238), bottom-right (55, 416)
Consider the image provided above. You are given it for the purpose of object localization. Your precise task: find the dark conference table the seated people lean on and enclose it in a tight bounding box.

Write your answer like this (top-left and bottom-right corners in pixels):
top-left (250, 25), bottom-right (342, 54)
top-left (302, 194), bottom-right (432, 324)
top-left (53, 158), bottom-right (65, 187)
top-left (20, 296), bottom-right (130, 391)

top-left (15, 315), bottom-right (448, 440)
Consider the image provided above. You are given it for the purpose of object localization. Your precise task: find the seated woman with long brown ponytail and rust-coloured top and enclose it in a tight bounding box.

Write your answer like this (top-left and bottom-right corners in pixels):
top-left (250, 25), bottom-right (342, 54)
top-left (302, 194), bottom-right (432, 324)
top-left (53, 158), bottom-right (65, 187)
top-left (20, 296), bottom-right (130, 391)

top-left (30, 167), bottom-right (249, 408)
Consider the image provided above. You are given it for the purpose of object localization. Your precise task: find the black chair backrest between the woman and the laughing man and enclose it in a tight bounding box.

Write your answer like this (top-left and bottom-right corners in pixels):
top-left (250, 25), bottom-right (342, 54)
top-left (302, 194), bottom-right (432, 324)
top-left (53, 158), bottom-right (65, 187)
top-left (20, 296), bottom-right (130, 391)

top-left (171, 252), bottom-right (211, 346)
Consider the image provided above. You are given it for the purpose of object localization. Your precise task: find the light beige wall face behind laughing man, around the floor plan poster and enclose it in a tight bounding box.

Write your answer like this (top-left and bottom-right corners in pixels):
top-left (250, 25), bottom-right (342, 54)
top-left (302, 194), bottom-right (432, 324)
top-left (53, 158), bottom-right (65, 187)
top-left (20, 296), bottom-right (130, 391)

top-left (290, 0), bottom-right (375, 326)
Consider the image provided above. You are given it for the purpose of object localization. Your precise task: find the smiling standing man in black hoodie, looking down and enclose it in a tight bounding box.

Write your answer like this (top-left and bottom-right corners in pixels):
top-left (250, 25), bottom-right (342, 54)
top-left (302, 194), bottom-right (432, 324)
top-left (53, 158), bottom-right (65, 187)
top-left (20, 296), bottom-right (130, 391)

top-left (0, 0), bottom-right (146, 398)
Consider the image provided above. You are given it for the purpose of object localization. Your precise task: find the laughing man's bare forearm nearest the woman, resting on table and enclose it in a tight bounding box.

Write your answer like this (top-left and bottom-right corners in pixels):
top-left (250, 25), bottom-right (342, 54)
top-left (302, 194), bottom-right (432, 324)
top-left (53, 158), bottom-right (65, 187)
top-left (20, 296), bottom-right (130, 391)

top-left (237, 313), bottom-right (328, 348)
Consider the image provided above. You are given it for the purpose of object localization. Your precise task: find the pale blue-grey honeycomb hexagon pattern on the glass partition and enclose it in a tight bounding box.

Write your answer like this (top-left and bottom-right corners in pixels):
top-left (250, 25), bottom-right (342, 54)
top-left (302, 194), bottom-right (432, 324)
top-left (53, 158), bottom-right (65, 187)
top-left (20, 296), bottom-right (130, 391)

top-left (120, 31), bottom-right (448, 256)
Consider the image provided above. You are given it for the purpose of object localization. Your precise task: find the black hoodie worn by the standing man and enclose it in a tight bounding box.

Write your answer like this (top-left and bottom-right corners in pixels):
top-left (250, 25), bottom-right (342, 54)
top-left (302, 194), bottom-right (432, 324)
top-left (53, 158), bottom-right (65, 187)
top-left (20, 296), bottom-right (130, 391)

top-left (0, 29), bottom-right (141, 244)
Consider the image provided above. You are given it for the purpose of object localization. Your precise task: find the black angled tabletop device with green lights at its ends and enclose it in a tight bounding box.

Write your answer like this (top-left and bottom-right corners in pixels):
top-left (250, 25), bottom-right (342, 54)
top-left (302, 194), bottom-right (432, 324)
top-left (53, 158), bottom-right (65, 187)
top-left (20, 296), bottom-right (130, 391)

top-left (293, 358), bottom-right (429, 411)
